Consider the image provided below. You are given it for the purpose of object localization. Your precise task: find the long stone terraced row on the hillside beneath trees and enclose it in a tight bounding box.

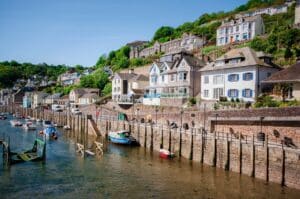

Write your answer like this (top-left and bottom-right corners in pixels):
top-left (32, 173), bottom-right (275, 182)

top-left (127, 33), bottom-right (205, 59)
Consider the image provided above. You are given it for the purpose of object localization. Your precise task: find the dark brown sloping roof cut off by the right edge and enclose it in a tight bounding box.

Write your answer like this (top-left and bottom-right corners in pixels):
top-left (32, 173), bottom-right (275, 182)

top-left (263, 62), bottom-right (300, 83)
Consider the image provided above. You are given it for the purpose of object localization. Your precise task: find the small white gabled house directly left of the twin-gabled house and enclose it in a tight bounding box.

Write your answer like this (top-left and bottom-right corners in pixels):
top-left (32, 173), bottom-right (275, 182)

top-left (112, 69), bottom-right (149, 104)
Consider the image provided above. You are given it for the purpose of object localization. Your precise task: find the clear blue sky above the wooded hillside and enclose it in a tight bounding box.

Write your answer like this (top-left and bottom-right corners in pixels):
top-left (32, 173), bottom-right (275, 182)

top-left (0, 0), bottom-right (247, 66)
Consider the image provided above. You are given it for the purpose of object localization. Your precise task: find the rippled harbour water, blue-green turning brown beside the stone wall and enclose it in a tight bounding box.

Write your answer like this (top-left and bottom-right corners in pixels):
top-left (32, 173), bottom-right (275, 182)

top-left (0, 114), bottom-right (300, 199)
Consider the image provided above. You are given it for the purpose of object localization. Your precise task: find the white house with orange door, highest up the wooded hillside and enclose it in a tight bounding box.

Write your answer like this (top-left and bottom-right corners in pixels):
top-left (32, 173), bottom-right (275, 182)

top-left (216, 15), bottom-right (265, 46)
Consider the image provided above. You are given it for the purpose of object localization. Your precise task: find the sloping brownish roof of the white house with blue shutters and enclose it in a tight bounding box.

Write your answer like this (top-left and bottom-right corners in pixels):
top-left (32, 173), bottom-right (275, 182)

top-left (200, 47), bottom-right (280, 71)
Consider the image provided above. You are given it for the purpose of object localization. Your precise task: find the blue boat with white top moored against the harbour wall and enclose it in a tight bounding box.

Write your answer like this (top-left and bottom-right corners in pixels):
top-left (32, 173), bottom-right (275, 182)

top-left (108, 130), bottom-right (137, 145)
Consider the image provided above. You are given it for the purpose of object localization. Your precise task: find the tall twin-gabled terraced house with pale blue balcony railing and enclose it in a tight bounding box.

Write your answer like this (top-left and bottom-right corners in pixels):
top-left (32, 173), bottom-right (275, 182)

top-left (143, 55), bottom-right (205, 106)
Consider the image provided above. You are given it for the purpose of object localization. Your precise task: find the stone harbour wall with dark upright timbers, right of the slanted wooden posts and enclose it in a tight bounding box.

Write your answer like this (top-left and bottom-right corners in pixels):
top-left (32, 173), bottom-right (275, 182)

top-left (97, 120), bottom-right (300, 189)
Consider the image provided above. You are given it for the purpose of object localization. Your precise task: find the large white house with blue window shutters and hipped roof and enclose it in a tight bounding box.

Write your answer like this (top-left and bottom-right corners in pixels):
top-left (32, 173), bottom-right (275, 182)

top-left (200, 47), bottom-right (281, 102)
